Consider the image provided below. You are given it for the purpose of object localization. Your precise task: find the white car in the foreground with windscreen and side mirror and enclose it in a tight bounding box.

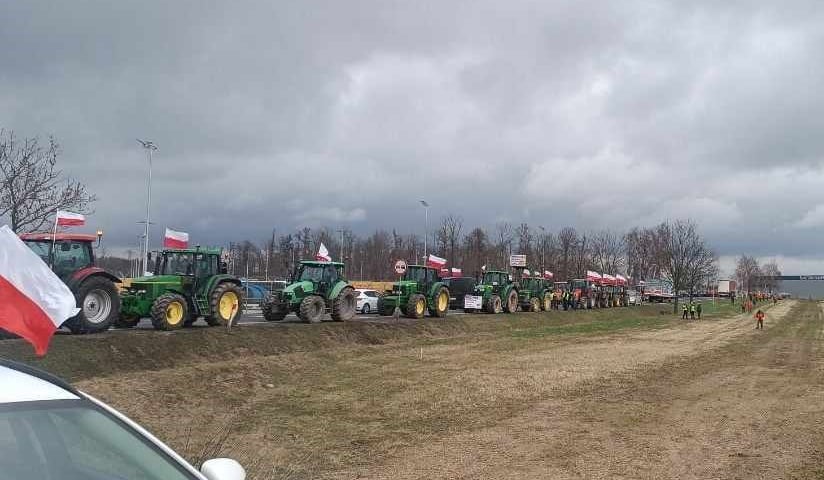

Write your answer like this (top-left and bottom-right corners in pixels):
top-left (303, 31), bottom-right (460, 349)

top-left (0, 359), bottom-right (246, 480)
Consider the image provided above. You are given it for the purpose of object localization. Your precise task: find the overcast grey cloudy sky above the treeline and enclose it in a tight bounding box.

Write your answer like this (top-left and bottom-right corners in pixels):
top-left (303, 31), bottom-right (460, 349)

top-left (0, 0), bottom-right (824, 273)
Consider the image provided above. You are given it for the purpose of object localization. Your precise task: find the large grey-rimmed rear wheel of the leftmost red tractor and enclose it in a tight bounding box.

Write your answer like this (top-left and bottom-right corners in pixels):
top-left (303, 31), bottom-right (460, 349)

top-left (64, 276), bottom-right (120, 333)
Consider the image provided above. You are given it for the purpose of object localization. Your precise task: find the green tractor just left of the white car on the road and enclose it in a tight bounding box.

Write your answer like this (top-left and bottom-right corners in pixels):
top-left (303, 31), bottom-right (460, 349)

top-left (261, 261), bottom-right (357, 323)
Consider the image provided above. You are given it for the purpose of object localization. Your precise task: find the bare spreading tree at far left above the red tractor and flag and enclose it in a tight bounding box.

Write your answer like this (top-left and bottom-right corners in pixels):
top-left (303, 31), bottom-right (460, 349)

top-left (0, 130), bottom-right (97, 232)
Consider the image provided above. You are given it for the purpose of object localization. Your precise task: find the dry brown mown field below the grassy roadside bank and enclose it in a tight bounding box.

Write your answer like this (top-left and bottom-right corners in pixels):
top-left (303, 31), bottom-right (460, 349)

top-left (69, 302), bottom-right (824, 479)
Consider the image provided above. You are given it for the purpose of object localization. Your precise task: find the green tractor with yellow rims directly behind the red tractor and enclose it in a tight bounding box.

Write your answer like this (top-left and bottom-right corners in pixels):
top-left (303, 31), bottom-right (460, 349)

top-left (115, 247), bottom-right (243, 330)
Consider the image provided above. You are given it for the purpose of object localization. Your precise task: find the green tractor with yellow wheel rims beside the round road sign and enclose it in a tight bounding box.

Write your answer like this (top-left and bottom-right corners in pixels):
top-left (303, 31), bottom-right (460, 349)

top-left (378, 265), bottom-right (449, 318)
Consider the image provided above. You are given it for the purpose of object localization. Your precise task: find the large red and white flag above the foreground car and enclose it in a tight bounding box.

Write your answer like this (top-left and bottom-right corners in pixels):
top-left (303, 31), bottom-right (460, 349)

top-left (0, 226), bottom-right (80, 356)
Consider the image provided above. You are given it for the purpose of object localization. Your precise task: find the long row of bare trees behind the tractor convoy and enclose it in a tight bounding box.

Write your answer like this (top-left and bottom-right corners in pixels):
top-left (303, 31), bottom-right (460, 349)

top-left (211, 215), bottom-right (717, 300)
